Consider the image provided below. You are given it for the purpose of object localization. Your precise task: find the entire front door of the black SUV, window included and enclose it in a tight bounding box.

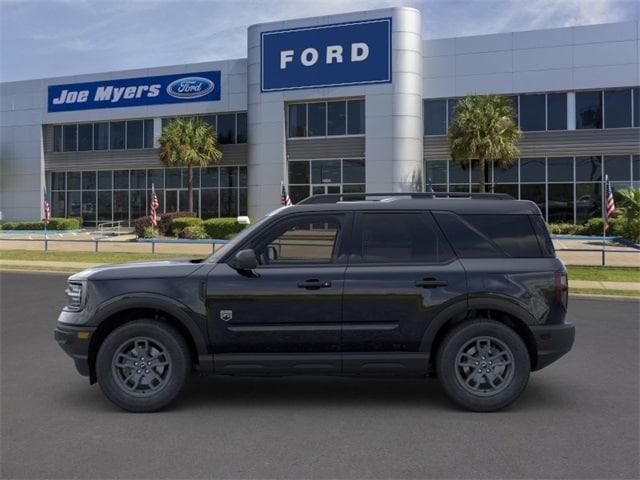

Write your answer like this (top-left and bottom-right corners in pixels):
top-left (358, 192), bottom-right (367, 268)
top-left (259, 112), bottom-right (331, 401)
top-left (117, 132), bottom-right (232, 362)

top-left (207, 214), bottom-right (348, 358)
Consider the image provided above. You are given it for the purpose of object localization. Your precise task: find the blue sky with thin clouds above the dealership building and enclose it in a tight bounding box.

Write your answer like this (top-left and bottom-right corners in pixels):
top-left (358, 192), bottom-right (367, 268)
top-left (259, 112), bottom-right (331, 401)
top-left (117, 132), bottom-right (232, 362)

top-left (0, 0), bottom-right (640, 81)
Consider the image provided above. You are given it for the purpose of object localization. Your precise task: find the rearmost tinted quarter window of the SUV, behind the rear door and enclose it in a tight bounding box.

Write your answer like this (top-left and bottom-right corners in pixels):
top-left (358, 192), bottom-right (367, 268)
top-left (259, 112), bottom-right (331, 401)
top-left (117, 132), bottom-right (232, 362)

top-left (437, 213), bottom-right (542, 258)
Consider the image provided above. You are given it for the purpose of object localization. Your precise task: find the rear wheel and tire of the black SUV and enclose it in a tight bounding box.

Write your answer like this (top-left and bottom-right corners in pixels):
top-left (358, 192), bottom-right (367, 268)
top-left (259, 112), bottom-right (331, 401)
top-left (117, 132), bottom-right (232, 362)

top-left (436, 319), bottom-right (531, 412)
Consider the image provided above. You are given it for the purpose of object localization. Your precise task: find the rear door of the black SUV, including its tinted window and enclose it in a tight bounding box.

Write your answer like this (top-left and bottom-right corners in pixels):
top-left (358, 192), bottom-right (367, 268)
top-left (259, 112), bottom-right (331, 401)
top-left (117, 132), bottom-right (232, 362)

top-left (342, 212), bottom-right (467, 372)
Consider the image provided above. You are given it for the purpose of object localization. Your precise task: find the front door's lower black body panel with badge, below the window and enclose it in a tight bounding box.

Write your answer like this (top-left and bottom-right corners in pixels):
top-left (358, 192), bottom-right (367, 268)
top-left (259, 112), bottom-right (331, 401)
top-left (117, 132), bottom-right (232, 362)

top-left (207, 264), bottom-right (345, 353)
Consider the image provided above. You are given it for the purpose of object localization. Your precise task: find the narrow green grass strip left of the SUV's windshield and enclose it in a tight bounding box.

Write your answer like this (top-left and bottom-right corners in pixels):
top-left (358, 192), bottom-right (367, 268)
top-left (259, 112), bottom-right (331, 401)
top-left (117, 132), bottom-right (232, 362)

top-left (0, 250), bottom-right (202, 263)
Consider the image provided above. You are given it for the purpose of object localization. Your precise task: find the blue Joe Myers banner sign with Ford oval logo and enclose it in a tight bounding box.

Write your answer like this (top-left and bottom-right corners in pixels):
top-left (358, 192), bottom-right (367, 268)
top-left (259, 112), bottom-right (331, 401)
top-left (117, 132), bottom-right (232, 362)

top-left (48, 70), bottom-right (220, 112)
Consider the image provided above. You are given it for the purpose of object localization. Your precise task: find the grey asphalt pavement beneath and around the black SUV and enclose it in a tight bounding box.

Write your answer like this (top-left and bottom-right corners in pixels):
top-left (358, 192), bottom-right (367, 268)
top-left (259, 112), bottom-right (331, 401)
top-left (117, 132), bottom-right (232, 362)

top-left (0, 272), bottom-right (640, 478)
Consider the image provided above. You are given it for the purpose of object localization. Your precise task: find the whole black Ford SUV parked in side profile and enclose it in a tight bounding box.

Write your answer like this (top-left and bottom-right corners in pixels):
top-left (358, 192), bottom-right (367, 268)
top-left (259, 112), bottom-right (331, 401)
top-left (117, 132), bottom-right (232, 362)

top-left (55, 193), bottom-right (574, 412)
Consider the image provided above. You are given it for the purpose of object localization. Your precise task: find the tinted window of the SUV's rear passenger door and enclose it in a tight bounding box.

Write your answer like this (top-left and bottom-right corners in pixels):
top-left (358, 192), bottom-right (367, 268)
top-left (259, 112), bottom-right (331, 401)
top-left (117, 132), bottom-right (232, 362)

top-left (357, 212), bottom-right (454, 263)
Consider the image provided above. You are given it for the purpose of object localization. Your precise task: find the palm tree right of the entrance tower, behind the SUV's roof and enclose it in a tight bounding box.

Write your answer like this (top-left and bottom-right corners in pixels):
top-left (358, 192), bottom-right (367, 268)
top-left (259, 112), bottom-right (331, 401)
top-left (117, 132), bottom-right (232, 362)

top-left (448, 95), bottom-right (522, 192)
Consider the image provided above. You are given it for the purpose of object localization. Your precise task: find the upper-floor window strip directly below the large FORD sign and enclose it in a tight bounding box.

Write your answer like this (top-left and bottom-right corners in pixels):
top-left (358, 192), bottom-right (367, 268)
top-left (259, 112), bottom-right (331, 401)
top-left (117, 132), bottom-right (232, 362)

top-left (287, 99), bottom-right (365, 138)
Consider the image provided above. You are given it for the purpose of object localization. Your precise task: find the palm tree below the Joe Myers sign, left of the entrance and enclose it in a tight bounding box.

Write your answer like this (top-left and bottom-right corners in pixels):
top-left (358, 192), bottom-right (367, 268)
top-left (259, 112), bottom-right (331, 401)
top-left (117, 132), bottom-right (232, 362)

top-left (158, 118), bottom-right (222, 212)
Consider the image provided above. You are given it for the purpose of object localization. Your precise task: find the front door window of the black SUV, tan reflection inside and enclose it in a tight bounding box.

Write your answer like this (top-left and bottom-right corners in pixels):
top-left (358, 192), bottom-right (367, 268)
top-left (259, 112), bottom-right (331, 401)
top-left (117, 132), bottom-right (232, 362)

top-left (255, 215), bottom-right (342, 265)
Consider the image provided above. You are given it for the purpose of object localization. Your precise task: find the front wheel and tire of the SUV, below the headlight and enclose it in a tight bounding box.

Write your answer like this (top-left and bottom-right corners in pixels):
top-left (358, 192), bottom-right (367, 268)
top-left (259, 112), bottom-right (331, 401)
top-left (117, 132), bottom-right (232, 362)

top-left (96, 319), bottom-right (191, 412)
